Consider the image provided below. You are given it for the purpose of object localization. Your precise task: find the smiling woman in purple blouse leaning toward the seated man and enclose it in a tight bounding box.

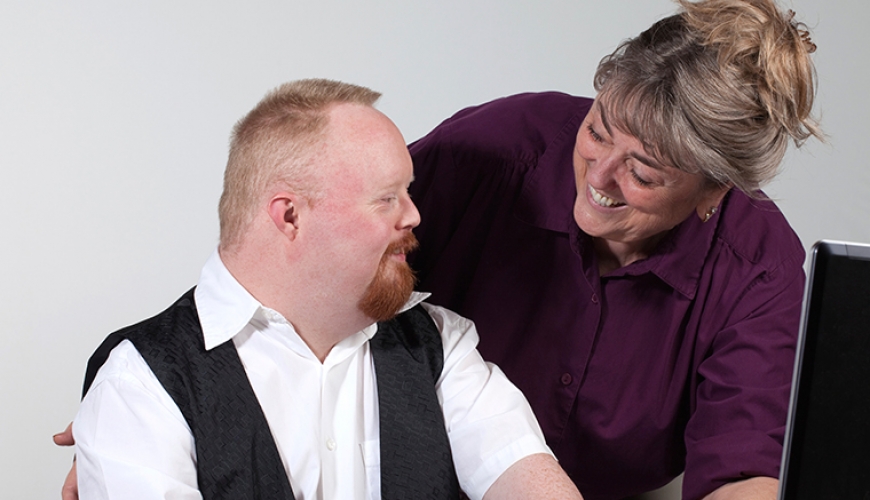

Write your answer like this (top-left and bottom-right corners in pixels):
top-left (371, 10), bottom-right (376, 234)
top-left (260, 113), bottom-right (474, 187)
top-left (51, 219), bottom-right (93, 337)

top-left (411, 0), bottom-right (820, 500)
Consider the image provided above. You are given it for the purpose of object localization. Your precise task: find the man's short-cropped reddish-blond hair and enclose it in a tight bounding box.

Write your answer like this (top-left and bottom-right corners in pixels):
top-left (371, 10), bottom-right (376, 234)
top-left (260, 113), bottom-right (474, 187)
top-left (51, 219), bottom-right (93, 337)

top-left (218, 79), bottom-right (381, 249)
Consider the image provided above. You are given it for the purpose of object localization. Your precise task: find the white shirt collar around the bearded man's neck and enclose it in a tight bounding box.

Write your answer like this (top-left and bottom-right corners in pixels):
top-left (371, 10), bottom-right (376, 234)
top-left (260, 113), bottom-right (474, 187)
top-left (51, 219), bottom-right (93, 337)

top-left (194, 250), bottom-right (430, 350)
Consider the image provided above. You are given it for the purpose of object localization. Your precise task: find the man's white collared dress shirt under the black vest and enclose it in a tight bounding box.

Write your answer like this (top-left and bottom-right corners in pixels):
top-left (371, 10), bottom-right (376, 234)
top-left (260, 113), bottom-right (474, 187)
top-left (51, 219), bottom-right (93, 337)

top-left (73, 251), bottom-right (552, 500)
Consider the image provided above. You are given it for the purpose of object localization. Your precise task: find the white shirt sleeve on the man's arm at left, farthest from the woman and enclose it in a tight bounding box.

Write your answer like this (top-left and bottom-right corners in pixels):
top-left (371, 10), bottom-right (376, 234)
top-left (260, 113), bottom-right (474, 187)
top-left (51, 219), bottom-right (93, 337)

top-left (73, 340), bottom-right (202, 500)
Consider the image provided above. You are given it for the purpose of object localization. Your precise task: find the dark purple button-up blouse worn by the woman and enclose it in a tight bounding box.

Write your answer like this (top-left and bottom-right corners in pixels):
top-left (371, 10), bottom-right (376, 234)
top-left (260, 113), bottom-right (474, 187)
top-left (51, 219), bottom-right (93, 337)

top-left (410, 93), bottom-right (804, 500)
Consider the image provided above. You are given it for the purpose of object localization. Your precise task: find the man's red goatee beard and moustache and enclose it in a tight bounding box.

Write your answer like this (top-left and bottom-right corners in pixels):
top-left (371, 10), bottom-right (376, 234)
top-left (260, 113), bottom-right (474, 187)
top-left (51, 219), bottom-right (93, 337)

top-left (358, 232), bottom-right (419, 321)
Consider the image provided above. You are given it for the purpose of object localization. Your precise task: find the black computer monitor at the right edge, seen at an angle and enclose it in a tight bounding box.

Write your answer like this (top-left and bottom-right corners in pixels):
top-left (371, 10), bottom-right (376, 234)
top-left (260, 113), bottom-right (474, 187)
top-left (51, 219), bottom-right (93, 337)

top-left (781, 242), bottom-right (870, 500)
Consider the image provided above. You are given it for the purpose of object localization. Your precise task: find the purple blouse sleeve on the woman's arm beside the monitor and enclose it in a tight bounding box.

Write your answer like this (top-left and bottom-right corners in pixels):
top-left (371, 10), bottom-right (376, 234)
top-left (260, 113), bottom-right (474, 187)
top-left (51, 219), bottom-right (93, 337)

top-left (683, 251), bottom-right (804, 498)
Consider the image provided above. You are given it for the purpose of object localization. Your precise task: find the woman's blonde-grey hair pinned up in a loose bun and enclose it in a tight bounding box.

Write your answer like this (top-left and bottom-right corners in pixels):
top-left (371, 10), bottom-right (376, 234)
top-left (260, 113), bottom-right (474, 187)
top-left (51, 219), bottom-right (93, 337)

top-left (595, 0), bottom-right (822, 196)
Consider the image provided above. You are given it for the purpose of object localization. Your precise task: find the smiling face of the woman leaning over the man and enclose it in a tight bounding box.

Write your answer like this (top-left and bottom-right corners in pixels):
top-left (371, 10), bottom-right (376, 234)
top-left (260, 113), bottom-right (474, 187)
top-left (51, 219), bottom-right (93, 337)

top-left (574, 101), bottom-right (727, 252)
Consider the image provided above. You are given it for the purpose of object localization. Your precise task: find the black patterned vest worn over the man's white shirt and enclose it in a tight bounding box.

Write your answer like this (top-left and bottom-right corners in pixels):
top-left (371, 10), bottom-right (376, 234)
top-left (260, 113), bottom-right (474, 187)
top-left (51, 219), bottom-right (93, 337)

top-left (83, 290), bottom-right (459, 500)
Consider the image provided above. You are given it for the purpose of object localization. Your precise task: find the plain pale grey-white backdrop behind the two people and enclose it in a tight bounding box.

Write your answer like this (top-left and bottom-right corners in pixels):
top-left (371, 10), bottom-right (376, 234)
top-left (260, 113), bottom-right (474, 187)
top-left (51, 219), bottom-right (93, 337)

top-left (0, 0), bottom-right (870, 499)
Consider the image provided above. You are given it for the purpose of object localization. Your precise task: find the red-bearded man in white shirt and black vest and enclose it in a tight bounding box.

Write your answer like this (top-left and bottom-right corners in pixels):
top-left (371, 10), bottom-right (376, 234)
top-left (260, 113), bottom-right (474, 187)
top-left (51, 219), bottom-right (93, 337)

top-left (73, 80), bottom-right (581, 500)
